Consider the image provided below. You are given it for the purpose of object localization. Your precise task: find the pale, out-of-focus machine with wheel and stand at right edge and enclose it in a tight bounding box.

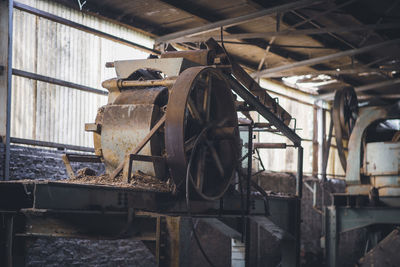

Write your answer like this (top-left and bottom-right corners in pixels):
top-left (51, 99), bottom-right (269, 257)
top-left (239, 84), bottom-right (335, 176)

top-left (325, 88), bottom-right (400, 266)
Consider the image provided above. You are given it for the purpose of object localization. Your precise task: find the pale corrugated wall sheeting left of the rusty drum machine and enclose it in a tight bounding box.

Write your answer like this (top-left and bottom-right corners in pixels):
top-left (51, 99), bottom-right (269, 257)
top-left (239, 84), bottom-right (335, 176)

top-left (11, 0), bottom-right (153, 146)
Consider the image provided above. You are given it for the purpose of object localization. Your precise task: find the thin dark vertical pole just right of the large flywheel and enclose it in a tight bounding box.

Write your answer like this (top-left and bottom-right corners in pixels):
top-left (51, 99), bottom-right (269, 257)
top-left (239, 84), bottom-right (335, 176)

top-left (245, 124), bottom-right (253, 267)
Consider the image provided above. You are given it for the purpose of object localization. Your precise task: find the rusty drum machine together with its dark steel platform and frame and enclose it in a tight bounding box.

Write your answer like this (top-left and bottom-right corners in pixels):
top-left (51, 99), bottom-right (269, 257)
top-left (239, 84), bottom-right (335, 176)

top-left (0, 39), bottom-right (303, 266)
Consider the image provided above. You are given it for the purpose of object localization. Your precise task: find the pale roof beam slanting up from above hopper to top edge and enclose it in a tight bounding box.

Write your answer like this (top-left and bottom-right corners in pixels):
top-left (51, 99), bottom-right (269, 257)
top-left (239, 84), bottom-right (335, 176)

top-left (156, 0), bottom-right (326, 43)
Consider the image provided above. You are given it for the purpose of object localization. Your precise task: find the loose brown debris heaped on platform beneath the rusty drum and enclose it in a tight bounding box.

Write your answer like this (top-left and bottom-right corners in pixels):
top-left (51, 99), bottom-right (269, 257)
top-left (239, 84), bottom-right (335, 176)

top-left (66, 168), bottom-right (175, 192)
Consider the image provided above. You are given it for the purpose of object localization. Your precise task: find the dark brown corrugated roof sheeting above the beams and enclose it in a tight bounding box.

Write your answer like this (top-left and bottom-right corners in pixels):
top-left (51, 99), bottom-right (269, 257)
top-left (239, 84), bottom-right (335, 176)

top-left (49, 0), bottom-right (400, 101)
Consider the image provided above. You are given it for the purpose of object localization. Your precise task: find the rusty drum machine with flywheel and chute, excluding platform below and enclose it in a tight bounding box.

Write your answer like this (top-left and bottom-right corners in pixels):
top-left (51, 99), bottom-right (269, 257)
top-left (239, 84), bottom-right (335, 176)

top-left (79, 41), bottom-right (291, 200)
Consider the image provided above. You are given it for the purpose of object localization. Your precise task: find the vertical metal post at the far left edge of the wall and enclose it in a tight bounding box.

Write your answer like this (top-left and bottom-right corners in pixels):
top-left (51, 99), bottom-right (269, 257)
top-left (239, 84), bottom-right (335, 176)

top-left (0, 0), bottom-right (13, 180)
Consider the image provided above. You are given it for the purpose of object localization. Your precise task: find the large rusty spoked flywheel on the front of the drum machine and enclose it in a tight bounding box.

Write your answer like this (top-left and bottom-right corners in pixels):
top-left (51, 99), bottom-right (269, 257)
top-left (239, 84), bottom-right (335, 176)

top-left (165, 66), bottom-right (239, 200)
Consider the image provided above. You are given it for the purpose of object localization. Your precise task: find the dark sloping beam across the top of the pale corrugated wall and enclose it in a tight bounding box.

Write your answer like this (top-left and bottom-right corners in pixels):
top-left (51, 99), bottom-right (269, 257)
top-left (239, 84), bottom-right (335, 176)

top-left (14, 2), bottom-right (160, 54)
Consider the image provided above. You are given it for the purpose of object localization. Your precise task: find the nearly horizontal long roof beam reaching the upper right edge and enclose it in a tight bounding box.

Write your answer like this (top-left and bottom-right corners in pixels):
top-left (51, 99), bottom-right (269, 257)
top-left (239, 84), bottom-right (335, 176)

top-left (175, 23), bottom-right (400, 42)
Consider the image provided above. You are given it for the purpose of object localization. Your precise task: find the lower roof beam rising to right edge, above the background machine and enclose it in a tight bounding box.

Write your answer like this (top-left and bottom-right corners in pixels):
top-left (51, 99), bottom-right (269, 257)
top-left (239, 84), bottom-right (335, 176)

top-left (252, 39), bottom-right (400, 77)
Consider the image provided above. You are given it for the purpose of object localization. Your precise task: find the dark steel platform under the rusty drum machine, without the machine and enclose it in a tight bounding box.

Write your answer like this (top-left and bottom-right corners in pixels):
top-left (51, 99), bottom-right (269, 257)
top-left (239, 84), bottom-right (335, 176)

top-left (0, 181), bottom-right (300, 267)
